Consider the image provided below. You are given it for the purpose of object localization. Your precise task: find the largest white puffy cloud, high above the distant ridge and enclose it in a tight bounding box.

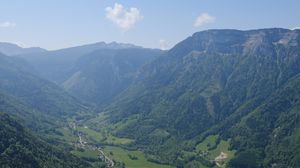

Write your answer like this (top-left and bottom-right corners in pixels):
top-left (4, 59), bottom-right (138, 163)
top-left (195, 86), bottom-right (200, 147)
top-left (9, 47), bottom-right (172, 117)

top-left (105, 3), bottom-right (143, 30)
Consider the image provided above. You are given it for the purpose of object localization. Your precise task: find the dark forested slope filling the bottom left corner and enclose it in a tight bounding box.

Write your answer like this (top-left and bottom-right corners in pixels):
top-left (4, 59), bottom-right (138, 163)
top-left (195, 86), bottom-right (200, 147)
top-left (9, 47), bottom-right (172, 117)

top-left (0, 113), bottom-right (91, 168)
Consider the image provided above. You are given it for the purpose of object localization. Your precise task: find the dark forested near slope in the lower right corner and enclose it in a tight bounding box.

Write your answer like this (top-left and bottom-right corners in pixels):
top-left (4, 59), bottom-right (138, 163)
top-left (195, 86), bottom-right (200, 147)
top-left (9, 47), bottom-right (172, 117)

top-left (226, 74), bottom-right (300, 167)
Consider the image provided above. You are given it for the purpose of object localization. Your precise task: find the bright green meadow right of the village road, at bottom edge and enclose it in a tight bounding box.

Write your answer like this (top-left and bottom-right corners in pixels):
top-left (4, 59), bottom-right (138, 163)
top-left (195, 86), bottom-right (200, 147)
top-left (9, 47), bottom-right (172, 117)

top-left (104, 146), bottom-right (170, 168)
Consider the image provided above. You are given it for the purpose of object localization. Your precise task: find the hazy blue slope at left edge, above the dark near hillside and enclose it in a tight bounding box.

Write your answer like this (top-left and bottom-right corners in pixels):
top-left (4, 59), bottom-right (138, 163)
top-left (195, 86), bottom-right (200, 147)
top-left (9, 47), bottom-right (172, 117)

top-left (0, 51), bottom-right (87, 118)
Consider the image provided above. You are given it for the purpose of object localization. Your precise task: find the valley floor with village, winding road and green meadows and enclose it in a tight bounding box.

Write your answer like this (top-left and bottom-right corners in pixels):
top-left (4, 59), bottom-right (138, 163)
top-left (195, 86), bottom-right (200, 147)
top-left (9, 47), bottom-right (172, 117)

top-left (49, 117), bottom-right (171, 168)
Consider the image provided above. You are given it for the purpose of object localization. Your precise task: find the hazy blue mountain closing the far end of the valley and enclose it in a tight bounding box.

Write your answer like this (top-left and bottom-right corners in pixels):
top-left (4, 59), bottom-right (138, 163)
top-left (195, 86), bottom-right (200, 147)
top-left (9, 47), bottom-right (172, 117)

top-left (14, 42), bottom-right (162, 105)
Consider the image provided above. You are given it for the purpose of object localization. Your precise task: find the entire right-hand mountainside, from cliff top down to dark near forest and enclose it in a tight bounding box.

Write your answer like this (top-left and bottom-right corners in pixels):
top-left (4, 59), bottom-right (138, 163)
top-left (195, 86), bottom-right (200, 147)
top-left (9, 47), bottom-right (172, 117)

top-left (91, 28), bottom-right (300, 167)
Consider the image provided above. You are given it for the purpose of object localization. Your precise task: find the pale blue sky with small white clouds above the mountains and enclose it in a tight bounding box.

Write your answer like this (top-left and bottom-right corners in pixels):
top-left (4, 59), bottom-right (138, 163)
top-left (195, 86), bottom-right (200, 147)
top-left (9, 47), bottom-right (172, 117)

top-left (0, 0), bottom-right (300, 50)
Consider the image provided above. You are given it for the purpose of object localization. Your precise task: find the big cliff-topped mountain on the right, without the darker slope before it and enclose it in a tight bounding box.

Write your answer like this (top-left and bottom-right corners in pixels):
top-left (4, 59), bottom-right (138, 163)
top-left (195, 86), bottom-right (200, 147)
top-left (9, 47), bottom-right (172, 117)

top-left (86, 29), bottom-right (300, 165)
